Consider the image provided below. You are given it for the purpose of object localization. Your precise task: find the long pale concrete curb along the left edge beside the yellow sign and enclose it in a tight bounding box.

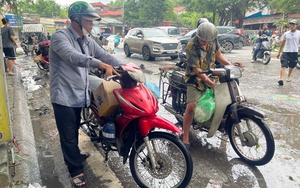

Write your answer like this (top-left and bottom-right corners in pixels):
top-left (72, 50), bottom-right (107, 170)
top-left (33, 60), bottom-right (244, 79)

top-left (6, 68), bottom-right (42, 188)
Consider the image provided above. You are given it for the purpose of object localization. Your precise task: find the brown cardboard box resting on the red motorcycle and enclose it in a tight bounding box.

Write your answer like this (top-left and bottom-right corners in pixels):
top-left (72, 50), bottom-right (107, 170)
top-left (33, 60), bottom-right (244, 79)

top-left (93, 81), bottom-right (121, 116)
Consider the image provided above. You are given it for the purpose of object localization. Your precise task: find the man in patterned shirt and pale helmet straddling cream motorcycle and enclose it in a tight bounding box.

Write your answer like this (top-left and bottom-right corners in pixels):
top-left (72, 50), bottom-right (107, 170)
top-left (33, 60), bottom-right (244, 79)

top-left (183, 21), bottom-right (243, 147)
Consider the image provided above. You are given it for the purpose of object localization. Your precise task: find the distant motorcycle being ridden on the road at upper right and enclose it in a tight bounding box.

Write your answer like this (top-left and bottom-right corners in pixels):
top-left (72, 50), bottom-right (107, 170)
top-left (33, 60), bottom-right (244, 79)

top-left (252, 34), bottom-right (272, 65)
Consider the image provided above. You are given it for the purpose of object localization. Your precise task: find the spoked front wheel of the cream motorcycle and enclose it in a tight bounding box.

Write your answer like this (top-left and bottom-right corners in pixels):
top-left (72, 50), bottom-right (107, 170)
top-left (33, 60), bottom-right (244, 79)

top-left (228, 115), bottom-right (275, 165)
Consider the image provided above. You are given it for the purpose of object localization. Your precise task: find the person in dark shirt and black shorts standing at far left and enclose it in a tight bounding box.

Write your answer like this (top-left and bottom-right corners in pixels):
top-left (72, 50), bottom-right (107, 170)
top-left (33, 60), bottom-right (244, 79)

top-left (1, 18), bottom-right (18, 76)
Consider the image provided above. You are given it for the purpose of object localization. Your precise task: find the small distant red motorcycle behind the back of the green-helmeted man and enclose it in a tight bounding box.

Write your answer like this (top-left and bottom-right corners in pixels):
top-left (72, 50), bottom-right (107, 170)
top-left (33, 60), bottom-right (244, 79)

top-left (34, 41), bottom-right (50, 72)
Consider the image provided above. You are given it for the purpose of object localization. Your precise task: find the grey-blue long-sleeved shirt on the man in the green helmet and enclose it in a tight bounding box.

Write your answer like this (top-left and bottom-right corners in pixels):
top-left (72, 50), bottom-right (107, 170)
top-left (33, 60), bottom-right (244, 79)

top-left (49, 25), bottom-right (122, 107)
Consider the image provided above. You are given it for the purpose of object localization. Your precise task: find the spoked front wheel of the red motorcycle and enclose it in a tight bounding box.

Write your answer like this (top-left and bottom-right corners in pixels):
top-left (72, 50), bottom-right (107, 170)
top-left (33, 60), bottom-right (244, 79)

top-left (130, 132), bottom-right (193, 187)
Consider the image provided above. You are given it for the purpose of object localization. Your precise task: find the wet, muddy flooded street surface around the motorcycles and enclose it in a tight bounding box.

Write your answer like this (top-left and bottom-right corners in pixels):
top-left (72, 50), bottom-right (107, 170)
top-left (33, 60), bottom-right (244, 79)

top-left (17, 47), bottom-right (300, 188)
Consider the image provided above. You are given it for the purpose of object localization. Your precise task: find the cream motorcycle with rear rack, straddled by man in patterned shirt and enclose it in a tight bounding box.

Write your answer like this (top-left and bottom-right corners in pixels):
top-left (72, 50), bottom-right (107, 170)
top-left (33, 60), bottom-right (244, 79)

top-left (160, 61), bottom-right (275, 165)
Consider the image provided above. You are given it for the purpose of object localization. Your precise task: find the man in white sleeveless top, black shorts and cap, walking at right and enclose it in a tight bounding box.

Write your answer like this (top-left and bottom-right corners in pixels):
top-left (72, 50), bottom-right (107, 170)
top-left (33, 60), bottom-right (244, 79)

top-left (277, 20), bottom-right (300, 86)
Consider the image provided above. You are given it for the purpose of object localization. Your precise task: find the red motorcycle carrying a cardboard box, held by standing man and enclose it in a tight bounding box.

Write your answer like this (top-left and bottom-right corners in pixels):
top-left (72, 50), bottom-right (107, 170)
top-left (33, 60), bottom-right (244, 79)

top-left (81, 64), bottom-right (193, 187)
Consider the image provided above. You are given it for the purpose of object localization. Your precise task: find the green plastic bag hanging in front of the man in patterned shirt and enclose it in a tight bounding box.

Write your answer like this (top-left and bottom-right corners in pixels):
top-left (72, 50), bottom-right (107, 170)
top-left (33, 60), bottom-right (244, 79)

top-left (194, 88), bottom-right (216, 123)
